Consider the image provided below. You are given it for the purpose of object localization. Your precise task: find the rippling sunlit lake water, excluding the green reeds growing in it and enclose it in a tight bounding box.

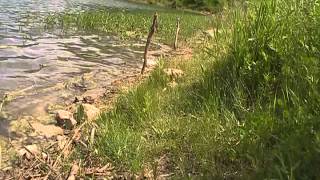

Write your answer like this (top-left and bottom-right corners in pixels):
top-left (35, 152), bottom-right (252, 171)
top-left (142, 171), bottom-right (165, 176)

top-left (0, 0), bottom-right (168, 128)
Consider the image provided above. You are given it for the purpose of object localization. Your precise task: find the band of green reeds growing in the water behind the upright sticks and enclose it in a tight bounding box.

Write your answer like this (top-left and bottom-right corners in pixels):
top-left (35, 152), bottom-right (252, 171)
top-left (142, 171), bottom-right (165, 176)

top-left (45, 9), bottom-right (211, 44)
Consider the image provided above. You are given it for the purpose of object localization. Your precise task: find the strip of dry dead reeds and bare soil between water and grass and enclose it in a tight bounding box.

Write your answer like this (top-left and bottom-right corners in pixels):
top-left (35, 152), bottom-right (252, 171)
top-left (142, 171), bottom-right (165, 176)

top-left (0, 45), bottom-right (193, 177)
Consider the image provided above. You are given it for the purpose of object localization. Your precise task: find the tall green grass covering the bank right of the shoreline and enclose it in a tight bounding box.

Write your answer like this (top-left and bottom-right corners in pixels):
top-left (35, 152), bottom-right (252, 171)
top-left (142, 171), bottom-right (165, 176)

top-left (90, 0), bottom-right (320, 179)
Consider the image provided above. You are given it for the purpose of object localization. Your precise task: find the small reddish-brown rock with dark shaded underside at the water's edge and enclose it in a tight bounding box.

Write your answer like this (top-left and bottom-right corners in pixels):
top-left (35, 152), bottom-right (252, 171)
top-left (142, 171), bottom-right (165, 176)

top-left (56, 110), bottom-right (77, 129)
